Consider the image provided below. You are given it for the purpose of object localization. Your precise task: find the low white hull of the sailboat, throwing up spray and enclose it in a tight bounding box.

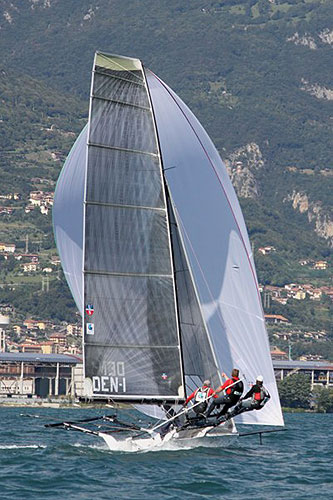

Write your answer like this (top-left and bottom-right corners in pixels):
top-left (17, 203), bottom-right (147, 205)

top-left (99, 427), bottom-right (238, 452)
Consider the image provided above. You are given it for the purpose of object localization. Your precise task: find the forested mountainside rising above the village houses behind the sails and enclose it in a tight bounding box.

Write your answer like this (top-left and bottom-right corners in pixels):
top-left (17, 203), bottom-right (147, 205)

top-left (0, 0), bottom-right (333, 334)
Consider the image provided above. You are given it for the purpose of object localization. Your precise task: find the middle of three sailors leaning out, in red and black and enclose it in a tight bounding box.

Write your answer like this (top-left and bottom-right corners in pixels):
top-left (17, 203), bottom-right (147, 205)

top-left (205, 368), bottom-right (243, 418)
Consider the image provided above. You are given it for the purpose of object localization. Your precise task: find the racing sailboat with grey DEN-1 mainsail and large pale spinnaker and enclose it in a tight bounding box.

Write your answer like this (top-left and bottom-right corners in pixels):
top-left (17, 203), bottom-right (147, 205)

top-left (53, 52), bottom-right (283, 449)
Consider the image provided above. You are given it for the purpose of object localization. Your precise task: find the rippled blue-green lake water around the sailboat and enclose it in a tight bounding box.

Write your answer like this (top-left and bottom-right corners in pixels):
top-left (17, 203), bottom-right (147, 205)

top-left (0, 407), bottom-right (333, 500)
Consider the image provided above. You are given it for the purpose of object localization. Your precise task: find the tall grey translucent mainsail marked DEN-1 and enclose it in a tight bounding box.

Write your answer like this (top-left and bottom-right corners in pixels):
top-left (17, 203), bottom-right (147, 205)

top-left (84, 53), bottom-right (184, 400)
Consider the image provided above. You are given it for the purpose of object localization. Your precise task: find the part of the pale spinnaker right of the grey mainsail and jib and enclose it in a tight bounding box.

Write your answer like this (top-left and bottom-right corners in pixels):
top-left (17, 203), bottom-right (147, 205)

top-left (146, 71), bottom-right (283, 425)
